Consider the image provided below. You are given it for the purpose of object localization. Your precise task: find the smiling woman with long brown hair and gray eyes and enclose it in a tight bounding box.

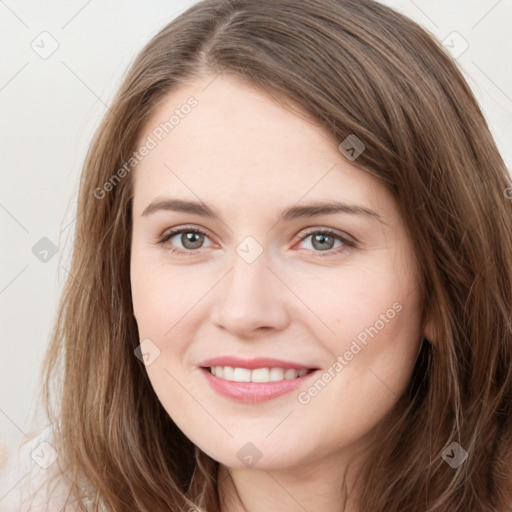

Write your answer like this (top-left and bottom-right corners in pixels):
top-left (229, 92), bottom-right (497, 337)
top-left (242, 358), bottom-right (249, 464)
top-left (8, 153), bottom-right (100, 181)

top-left (2, 0), bottom-right (512, 512)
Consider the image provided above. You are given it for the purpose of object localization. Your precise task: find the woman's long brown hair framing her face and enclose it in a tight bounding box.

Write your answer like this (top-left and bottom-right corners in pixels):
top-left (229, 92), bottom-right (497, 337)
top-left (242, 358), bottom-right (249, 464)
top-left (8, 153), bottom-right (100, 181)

top-left (42, 0), bottom-right (512, 512)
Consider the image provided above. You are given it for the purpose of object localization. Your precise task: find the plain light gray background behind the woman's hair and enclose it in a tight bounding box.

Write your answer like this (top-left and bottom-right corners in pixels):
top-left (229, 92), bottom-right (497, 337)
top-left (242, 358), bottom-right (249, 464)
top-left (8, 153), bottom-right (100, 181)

top-left (0, 0), bottom-right (512, 458)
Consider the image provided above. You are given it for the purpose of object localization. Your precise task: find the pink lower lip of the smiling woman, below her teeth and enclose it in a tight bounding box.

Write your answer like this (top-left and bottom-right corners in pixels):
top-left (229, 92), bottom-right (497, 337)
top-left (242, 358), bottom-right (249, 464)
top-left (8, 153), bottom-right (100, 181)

top-left (201, 368), bottom-right (318, 403)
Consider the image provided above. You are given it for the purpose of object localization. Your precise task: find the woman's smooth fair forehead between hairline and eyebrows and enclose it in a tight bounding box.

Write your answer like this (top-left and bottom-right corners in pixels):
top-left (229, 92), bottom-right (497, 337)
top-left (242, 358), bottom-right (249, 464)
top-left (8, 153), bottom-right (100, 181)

top-left (134, 75), bottom-right (389, 212)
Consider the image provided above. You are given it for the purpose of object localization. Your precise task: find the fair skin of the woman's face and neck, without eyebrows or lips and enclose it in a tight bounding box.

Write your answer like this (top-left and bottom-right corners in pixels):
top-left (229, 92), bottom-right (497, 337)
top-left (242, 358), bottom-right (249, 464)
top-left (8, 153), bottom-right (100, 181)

top-left (131, 75), bottom-right (422, 512)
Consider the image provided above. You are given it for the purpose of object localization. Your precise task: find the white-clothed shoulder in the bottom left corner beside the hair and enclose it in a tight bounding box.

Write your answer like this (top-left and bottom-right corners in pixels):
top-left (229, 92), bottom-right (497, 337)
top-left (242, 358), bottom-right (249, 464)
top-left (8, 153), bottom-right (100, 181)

top-left (0, 426), bottom-right (79, 512)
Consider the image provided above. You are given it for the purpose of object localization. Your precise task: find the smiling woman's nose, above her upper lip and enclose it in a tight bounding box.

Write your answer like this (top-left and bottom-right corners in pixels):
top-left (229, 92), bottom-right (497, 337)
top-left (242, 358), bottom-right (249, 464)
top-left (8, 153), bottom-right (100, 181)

top-left (212, 252), bottom-right (290, 339)
